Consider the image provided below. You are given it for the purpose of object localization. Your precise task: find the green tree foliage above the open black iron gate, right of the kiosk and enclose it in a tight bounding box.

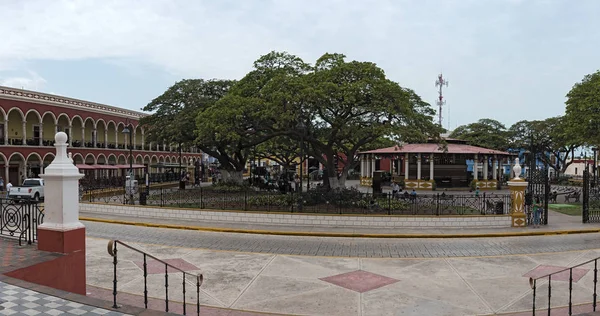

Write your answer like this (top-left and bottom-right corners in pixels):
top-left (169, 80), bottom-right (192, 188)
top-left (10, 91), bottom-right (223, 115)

top-left (509, 116), bottom-right (581, 173)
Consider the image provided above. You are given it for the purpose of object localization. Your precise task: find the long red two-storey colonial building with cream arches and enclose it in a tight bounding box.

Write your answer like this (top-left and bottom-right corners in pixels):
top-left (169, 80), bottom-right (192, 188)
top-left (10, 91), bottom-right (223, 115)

top-left (0, 86), bottom-right (202, 184)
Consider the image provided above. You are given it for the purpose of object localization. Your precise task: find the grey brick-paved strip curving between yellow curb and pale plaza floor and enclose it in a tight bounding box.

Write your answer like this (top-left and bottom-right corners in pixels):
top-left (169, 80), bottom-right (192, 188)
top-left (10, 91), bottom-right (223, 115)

top-left (84, 222), bottom-right (600, 258)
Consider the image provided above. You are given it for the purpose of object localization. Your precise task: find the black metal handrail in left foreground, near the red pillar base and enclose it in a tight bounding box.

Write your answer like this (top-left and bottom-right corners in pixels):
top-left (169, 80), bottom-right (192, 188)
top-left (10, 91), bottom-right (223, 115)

top-left (107, 240), bottom-right (204, 315)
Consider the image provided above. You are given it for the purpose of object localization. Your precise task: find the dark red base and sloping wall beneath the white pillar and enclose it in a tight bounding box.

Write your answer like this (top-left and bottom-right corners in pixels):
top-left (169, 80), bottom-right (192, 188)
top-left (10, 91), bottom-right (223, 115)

top-left (6, 228), bottom-right (86, 295)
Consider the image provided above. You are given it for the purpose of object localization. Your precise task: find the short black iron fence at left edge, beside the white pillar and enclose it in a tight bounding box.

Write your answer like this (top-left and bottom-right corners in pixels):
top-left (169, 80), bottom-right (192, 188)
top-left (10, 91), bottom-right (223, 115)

top-left (0, 199), bottom-right (44, 245)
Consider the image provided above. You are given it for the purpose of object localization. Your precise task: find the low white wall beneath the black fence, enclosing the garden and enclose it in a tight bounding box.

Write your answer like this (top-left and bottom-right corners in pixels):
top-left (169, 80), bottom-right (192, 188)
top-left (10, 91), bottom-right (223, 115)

top-left (79, 203), bottom-right (511, 228)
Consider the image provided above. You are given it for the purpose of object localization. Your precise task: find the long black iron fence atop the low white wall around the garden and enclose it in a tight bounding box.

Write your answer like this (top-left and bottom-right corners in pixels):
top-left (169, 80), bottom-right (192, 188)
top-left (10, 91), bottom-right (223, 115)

top-left (83, 186), bottom-right (511, 215)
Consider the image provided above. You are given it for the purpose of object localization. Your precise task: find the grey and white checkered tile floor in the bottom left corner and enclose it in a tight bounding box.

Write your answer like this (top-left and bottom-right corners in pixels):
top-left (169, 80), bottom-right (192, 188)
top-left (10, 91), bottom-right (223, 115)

top-left (0, 282), bottom-right (127, 316)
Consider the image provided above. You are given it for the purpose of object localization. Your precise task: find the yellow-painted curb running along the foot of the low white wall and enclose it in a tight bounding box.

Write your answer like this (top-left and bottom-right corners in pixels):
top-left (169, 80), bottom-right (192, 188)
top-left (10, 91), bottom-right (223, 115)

top-left (79, 217), bottom-right (600, 238)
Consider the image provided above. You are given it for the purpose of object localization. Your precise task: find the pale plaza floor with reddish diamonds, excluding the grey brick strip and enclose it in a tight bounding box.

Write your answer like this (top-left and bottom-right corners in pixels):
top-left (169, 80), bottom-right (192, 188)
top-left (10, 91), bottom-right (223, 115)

top-left (87, 237), bottom-right (600, 316)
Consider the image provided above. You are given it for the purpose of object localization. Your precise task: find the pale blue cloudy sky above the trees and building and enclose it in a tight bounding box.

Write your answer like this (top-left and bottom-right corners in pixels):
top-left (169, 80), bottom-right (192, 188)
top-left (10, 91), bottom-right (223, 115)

top-left (0, 0), bottom-right (600, 129)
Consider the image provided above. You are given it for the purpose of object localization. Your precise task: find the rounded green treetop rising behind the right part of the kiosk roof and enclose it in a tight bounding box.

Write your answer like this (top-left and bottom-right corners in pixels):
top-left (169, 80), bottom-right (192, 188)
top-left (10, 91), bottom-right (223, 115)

top-left (450, 119), bottom-right (510, 150)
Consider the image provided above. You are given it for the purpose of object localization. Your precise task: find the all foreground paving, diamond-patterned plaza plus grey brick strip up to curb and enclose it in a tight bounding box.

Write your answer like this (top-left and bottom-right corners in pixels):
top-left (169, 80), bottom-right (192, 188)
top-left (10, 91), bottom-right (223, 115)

top-left (86, 223), bottom-right (600, 315)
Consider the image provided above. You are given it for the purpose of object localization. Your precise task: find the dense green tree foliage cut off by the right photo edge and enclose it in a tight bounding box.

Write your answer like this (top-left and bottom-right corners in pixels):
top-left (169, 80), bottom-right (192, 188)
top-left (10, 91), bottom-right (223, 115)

top-left (565, 70), bottom-right (600, 146)
